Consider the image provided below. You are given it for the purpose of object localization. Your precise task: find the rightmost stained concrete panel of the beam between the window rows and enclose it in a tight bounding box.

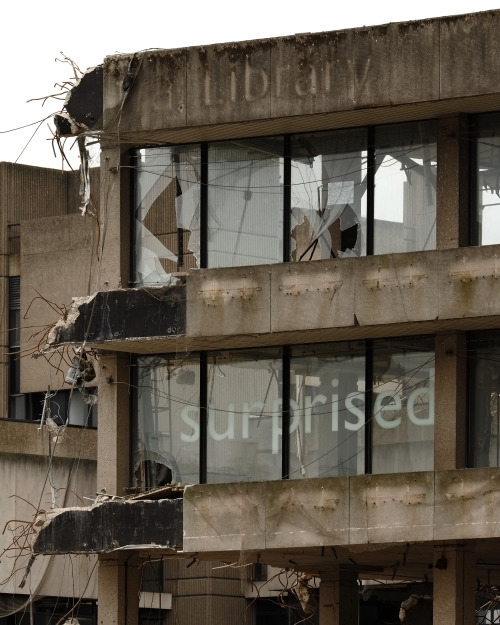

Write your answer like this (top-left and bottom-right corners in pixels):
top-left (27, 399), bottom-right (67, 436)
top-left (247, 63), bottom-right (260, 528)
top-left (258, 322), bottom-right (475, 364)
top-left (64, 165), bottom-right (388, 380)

top-left (436, 245), bottom-right (500, 319)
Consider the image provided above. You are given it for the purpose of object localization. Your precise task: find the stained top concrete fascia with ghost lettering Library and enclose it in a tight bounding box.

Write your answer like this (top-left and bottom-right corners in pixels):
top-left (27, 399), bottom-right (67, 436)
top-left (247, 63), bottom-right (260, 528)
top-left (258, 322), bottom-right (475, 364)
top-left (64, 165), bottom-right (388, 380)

top-left (104, 11), bottom-right (500, 140)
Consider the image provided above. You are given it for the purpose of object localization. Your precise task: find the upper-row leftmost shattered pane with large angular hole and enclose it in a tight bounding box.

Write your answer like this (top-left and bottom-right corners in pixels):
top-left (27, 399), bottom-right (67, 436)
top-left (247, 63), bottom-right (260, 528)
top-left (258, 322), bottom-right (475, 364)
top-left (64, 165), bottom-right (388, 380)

top-left (134, 145), bottom-right (200, 285)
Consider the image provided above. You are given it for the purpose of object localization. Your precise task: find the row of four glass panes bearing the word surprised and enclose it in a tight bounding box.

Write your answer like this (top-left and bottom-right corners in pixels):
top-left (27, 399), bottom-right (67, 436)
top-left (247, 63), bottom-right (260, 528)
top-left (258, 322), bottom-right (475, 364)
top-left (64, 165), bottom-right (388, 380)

top-left (133, 337), bottom-right (434, 488)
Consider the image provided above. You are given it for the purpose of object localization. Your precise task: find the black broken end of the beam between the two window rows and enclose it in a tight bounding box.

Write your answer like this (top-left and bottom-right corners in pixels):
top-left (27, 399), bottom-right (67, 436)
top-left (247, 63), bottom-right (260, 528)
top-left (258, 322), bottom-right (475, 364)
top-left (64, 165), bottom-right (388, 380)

top-left (55, 285), bottom-right (186, 343)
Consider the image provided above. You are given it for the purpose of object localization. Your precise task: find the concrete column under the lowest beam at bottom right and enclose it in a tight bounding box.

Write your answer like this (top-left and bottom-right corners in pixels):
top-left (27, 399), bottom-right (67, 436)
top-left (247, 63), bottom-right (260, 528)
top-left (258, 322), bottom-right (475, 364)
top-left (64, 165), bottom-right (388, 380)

top-left (433, 547), bottom-right (476, 625)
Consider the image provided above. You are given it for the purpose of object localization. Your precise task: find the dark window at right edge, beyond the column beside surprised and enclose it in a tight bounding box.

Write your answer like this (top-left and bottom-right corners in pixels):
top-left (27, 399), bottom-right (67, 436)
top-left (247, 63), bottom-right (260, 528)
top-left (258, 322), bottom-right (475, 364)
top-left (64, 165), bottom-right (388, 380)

top-left (469, 331), bottom-right (500, 467)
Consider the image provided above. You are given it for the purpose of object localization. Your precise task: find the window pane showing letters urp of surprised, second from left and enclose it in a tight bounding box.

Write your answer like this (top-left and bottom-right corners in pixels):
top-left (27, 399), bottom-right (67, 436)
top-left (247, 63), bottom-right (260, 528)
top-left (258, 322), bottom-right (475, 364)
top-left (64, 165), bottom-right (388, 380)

top-left (207, 349), bottom-right (282, 482)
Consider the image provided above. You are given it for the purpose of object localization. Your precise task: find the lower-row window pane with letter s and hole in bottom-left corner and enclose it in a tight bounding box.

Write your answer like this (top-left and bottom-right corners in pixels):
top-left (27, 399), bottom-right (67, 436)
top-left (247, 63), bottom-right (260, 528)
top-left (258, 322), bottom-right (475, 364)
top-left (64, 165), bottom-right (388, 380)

top-left (133, 356), bottom-right (200, 490)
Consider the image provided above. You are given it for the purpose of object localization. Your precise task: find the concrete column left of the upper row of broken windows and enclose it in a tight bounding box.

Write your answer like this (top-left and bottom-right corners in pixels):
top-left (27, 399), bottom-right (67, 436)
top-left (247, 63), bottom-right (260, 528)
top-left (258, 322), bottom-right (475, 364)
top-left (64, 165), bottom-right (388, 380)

top-left (91, 145), bottom-right (131, 291)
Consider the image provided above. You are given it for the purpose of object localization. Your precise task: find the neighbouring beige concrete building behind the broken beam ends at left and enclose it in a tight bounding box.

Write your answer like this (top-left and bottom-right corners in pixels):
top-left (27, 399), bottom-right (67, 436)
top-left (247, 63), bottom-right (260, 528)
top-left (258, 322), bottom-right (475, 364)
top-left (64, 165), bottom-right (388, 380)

top-left (0, 163), bottom-right (98, 625)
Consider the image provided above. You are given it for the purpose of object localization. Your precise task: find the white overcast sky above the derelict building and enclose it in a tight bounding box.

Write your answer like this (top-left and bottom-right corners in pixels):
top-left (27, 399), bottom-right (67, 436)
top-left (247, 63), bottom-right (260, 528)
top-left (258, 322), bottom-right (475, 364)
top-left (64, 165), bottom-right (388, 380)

top-left (0, 0), bottom-right (499, 169)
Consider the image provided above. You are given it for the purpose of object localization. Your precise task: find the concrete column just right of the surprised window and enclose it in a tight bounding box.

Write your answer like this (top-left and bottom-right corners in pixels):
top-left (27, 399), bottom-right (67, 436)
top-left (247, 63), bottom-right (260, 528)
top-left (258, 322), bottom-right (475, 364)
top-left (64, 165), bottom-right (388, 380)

top-left (434, 333), bottom-right (467, 471)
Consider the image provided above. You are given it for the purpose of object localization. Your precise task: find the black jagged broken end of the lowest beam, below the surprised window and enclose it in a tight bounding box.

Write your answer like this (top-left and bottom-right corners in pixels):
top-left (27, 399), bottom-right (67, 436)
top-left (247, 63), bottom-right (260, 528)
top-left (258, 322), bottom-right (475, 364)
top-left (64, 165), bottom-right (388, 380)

top-left (33, 499), bottom-right (182, 554)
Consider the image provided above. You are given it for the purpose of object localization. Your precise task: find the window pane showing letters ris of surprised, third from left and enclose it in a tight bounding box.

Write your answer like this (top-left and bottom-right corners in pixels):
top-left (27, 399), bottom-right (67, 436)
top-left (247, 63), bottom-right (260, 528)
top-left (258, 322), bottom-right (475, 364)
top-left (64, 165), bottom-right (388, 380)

top-left (290, 342), bottom-right (365, 479)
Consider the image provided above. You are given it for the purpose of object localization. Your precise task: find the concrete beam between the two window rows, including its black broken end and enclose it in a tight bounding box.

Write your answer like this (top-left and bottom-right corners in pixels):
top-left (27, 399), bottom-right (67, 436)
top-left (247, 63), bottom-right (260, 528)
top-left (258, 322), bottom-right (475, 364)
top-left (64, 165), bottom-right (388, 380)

top-left (47, 245), bottom-right (500, 353)
